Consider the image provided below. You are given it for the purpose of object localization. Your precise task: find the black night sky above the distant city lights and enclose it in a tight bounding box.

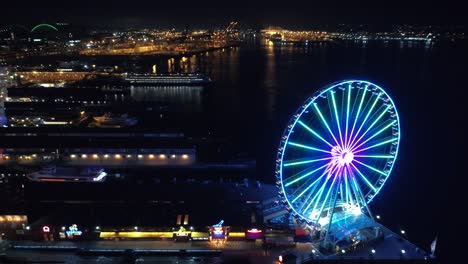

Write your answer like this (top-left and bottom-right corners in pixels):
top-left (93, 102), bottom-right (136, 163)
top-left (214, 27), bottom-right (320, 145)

top-left (0, 0), bottom-right (467, 29)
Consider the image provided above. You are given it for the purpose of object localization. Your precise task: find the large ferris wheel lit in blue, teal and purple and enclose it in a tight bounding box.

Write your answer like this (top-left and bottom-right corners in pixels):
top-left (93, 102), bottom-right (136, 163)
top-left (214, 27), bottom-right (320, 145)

top-left (276, 80), bottom-right (400, 226)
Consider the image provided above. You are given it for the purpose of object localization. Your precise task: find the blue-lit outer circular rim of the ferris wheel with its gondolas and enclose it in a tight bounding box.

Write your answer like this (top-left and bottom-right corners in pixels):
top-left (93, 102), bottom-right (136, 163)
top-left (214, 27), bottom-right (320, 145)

top-left (275, 79), bottom-right (401, 224)
